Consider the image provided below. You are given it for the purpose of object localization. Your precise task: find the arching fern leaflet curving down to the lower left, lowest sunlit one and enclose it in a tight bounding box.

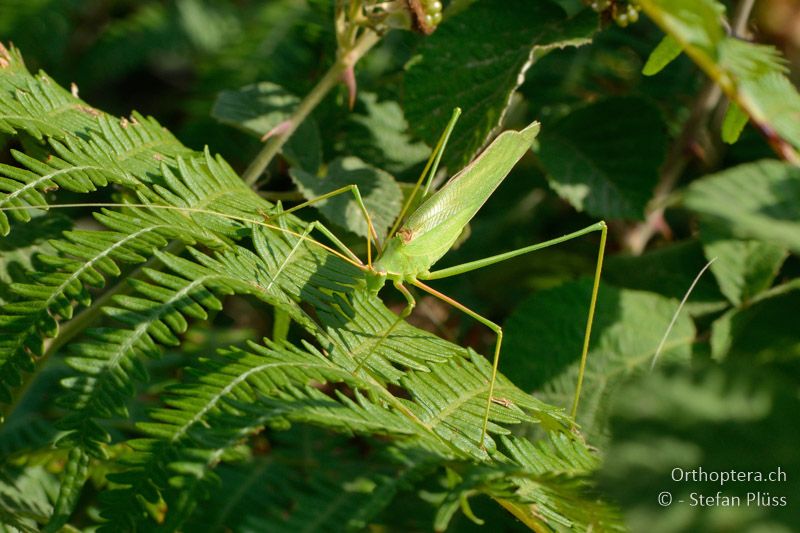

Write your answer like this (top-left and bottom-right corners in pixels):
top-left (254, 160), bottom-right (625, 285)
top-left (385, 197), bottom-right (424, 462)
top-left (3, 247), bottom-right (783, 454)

top-left (95, 336), bottom-right (414, 528)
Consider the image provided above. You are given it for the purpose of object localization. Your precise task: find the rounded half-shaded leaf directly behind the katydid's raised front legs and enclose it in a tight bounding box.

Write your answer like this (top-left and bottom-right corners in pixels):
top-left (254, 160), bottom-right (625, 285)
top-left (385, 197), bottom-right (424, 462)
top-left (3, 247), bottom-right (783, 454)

top-left (290, 157), bottom-right (402, 236)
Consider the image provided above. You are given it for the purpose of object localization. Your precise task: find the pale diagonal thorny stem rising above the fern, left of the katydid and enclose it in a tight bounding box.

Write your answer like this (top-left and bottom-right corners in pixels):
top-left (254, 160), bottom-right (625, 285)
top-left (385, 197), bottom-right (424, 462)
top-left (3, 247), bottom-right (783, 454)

top-left (242, 30), bottom-right (380, 185)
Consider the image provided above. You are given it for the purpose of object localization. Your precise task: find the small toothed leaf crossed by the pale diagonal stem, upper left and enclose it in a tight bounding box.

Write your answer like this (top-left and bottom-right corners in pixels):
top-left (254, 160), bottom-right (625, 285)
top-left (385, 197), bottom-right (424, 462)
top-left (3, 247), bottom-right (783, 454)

top-left (216, 81), bottom-right (322, 172)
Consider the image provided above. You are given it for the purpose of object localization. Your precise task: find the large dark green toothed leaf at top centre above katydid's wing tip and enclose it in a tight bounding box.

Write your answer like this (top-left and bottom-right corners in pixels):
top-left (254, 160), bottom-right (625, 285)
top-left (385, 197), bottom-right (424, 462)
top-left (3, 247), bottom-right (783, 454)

top-left (403, 0), bottom-right (597, 168)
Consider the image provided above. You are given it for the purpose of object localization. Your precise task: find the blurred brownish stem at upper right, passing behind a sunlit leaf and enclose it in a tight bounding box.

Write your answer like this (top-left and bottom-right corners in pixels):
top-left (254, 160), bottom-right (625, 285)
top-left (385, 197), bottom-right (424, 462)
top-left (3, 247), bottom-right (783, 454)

top-left (623, 0), bottom-right (755, 255)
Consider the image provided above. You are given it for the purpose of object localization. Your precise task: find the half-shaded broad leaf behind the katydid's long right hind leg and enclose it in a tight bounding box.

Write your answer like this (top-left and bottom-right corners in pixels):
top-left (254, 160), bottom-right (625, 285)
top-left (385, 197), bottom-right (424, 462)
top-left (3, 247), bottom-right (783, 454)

top-left (500, 279), bottom-right (695, 443)
